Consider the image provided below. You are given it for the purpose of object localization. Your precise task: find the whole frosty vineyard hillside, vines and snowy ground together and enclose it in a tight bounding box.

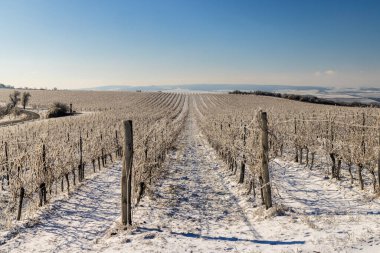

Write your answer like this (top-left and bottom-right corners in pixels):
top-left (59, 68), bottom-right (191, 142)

top-left (0, 91), bottom-right (380, 252)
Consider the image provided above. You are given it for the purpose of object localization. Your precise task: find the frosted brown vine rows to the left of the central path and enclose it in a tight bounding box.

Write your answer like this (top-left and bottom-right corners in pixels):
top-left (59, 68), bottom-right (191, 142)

top-left (0, 94), bottom-right (187, 226)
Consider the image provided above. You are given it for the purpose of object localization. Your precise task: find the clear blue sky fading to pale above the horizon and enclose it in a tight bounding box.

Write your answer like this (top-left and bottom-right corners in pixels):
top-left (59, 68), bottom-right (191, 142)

top-left (0, 0), bottom-right (380, 88)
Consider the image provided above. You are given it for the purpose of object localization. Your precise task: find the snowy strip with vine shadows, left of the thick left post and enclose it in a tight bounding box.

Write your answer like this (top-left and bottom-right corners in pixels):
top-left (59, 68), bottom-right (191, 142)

top-left (0, 165), bottom-right (121, 253)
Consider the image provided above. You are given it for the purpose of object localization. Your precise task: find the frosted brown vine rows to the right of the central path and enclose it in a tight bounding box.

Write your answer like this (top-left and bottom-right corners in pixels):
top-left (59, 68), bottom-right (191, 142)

top-left (195, 95), bottom-right (380, 199)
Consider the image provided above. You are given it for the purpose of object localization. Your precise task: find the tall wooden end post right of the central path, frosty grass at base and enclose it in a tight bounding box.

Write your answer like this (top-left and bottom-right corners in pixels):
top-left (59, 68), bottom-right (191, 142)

top-left (261, 112), bottom-right (272, 209)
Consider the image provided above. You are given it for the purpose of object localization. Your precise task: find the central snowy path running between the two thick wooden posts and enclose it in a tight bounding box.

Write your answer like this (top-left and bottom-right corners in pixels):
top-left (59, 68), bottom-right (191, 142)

top-left (99, 115), bottom-right (302, 252)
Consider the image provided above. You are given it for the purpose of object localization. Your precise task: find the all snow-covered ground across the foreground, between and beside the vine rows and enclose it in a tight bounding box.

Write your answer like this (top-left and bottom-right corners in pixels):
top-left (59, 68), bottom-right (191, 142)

top-left (0, 114), bottom-right (380, 252)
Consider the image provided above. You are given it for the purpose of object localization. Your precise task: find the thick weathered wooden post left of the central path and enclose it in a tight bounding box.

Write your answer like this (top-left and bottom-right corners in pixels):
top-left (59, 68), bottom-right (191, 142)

top-left (121, 120), bottom-right (133, 226)
